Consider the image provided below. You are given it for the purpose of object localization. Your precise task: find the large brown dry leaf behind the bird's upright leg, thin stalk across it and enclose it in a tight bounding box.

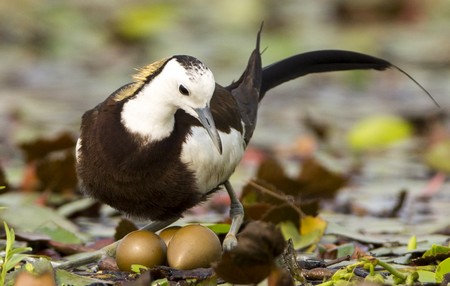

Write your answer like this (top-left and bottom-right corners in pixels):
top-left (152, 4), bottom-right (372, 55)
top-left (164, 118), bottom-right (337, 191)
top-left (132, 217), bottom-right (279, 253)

top-left (241, 156), bottom-right (338, 227)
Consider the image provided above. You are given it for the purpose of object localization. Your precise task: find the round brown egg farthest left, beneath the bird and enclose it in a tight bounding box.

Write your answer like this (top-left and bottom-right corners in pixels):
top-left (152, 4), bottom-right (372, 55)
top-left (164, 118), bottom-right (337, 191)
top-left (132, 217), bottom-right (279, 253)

top-left (116, 230), bottom-right (167, 271)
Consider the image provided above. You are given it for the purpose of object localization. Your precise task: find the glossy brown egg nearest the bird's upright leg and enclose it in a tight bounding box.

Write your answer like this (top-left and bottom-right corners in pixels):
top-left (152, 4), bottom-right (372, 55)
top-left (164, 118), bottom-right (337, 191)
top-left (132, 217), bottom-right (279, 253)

top-left (167, 224), bottom-right (222, 270)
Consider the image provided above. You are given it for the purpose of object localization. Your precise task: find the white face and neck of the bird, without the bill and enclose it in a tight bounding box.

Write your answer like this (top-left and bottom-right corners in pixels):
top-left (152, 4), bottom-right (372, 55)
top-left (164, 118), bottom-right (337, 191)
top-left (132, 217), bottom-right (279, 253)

top-left (121, 56), bottom-right (215, 141)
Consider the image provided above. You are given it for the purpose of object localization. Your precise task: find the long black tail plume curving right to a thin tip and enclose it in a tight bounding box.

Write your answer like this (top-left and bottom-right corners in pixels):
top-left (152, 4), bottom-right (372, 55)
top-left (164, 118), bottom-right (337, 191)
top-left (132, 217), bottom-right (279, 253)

top-left (259, 50), bottom-right (439, 106)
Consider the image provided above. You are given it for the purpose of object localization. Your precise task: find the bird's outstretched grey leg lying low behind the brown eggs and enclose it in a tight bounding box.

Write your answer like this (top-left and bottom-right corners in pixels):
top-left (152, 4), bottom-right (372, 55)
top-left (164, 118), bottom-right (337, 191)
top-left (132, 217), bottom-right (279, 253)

top-left (53, 218), bottom-right (178, 269)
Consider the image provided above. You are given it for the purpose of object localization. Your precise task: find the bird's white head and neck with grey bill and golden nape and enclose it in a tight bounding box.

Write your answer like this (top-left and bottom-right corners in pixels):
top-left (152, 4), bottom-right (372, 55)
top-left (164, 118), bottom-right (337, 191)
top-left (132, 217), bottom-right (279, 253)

top-left (116, 55), bottom-right (222, 153)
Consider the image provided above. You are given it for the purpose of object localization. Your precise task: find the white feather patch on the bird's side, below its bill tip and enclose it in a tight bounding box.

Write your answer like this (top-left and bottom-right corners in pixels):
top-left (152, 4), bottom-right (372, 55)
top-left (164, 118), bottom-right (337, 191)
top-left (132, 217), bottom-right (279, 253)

top-left (181, 127), bottom-right (245, 193)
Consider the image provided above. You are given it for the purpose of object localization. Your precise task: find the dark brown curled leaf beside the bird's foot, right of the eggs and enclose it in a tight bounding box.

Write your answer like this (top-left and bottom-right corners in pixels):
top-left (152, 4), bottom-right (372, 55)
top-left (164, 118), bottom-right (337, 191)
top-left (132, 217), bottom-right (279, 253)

top-left (213, 221), bottom-right (286, 284)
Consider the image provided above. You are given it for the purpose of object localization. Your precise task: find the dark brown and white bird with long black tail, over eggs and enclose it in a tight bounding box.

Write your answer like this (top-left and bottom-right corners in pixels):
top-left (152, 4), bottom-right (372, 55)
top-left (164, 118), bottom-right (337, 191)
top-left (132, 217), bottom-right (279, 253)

top-left (66, 25), bottom-right (437, 270)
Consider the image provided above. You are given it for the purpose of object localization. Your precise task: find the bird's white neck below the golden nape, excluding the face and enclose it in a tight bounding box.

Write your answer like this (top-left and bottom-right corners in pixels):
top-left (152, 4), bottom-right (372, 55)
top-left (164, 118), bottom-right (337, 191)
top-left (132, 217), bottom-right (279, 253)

top-left (121, 92), bottom-right (176, 143)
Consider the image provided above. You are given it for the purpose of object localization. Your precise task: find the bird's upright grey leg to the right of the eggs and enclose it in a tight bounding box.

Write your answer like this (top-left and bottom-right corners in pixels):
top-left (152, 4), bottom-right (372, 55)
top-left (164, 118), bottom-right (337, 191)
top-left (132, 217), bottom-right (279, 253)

top-left (223, 180), bottom-right (244, 250)
